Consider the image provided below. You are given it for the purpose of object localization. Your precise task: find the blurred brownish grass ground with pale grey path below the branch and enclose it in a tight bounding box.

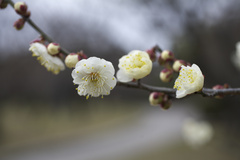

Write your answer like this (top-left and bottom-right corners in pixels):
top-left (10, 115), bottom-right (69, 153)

top-left (0, 102), bottom-right (236, 160)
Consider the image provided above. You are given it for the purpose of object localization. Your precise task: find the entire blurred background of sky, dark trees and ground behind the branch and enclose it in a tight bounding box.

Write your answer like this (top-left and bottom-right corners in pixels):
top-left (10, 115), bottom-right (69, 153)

top-left (0, 0), bottom-right (240, 160)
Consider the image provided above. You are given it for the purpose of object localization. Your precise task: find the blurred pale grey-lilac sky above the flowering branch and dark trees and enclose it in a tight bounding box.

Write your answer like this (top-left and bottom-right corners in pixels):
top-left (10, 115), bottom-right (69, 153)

top-left (0, 0), bottom-right (234, 56)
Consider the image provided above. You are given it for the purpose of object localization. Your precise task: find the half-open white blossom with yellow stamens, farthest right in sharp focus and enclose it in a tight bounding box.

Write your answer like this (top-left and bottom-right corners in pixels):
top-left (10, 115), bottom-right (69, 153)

top-left (174, 64), bottom-right (204, 98)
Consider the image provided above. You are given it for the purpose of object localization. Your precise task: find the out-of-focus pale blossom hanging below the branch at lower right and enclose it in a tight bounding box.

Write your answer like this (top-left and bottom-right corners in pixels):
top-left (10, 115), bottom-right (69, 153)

top-left (182, 118), bottom-right (213, 148)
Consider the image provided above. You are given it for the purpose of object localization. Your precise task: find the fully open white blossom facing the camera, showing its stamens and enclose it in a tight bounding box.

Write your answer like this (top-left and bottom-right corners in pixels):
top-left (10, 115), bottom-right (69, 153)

top-left (72, 57), bottom-right (117, 99)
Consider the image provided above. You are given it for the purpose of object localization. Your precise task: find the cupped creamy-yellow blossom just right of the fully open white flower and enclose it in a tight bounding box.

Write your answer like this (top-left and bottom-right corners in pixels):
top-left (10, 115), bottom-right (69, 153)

top-left (117, 50), bottom-right (152, 82)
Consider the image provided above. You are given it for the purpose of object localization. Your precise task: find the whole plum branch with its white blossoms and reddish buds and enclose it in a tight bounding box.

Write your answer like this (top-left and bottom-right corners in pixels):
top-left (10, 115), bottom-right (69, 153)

top-left (0, 0), bottom-right (240, 106)
